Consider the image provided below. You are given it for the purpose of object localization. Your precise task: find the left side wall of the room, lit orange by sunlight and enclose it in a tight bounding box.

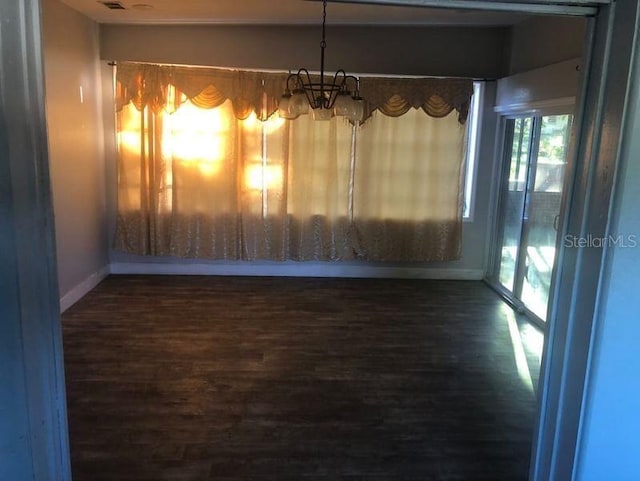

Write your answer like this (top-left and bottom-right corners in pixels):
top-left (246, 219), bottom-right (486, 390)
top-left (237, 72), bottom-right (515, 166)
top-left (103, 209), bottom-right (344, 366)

top-left (42, 0), bottom-right (108, 310)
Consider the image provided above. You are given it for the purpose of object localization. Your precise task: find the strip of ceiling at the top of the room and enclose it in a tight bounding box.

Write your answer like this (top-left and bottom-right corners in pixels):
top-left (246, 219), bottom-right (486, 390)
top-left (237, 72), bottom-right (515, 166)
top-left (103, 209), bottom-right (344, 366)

top-left (62, 0), bottom-right (527, 26)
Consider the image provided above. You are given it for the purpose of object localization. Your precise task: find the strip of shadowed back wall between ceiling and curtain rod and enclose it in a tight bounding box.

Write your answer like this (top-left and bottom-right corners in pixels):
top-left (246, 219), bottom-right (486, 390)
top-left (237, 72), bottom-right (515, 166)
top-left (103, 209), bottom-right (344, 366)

top-left (100, 25), bottom-right (508, 79)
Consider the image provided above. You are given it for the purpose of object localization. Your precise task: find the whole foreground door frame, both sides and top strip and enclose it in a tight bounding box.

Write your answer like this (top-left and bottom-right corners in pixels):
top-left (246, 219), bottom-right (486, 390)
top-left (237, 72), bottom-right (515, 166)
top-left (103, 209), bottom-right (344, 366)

top-left (0, 0), bottom-right (640, 481)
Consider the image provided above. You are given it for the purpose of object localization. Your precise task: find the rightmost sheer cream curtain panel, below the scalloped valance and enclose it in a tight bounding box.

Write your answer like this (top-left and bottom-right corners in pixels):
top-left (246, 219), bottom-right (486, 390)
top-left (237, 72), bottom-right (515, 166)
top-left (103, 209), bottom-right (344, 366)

top-left (354, 109), bottom-right (466, 261)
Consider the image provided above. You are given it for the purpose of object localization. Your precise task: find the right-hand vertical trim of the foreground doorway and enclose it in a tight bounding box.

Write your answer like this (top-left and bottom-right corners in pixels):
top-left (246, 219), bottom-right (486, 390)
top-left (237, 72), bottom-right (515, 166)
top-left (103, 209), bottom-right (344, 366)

top-left (530, 0), bottom-right (639, 481)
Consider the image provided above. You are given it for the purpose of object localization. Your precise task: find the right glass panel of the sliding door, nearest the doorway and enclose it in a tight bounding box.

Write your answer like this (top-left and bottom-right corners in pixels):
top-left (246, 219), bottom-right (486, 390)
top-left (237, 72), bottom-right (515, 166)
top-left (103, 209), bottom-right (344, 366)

top-left (519, 115), bottom-right (571, 320)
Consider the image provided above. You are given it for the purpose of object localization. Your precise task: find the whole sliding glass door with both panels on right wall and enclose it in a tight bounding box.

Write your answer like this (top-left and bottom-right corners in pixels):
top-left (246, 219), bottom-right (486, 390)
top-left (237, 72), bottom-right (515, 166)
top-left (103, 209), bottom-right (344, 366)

top-left (492, 115), bottom-right (571, 321)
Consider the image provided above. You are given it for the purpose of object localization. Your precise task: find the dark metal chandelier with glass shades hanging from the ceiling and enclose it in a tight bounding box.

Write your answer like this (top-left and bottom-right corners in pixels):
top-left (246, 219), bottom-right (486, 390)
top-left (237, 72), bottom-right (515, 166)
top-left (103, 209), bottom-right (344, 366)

top-left (278, 0), bottom-right (364, 122)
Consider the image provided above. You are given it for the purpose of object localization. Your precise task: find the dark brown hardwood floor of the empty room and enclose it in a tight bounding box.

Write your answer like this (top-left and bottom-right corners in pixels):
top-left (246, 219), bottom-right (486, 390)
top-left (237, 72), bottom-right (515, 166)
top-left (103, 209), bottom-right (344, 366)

top-left (63, 276), bottom-right (537, 481)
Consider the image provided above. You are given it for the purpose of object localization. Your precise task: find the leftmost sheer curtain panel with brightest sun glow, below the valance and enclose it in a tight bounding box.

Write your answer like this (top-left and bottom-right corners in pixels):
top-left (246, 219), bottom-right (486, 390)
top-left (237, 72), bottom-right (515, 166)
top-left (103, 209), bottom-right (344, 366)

top-left (116, 98), bottom-right (242, 259)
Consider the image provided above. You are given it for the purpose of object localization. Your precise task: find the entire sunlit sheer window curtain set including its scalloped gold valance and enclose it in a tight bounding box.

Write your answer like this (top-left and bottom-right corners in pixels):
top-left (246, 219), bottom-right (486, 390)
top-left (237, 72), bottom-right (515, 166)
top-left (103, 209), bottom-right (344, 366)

top-left (115, 65), bottom-right (472, 261)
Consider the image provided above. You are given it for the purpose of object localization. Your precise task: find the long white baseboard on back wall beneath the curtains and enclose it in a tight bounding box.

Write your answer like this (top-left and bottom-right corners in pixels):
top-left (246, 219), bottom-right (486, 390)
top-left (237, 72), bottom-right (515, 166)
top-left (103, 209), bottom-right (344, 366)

top-left (110, 262), bottom-right (484, 280)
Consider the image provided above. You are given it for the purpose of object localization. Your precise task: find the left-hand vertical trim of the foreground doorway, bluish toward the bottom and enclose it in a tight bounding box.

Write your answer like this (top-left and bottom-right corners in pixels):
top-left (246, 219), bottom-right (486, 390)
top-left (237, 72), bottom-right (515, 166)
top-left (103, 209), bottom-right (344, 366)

top-left (0, 0), bottom-right (71, 481)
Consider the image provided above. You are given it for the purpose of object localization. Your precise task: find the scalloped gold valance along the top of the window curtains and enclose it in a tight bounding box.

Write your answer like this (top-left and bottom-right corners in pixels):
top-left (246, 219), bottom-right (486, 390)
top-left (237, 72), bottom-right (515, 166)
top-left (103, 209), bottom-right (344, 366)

top-left (116, 62), bottom-right (473, 124)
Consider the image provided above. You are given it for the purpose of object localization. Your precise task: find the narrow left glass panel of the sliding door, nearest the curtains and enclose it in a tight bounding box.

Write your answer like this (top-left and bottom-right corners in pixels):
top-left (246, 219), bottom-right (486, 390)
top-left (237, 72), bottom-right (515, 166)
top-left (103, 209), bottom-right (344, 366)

top-left (498, 117), bottom-right (533, 292)
